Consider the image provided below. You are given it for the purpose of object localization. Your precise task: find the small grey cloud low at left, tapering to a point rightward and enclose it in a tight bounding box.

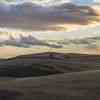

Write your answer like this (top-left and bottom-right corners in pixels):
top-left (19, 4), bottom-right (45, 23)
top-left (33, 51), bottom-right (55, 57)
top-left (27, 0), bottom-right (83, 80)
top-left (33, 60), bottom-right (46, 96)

top-left (0, 34), bottom-right (62, 48)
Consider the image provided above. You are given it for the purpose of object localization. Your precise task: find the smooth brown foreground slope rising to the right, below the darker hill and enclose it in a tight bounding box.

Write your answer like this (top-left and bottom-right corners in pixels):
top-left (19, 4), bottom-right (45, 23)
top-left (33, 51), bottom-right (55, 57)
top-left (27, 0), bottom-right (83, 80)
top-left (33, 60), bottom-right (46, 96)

top-left (0, 70), bottom-right (100, 100)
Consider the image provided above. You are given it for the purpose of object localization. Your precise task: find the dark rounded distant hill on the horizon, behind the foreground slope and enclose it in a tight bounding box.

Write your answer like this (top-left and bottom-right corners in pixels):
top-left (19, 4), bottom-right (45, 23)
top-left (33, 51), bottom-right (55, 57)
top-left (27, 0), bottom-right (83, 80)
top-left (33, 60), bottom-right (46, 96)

top-left (0, 52), bottom-right (100, 77)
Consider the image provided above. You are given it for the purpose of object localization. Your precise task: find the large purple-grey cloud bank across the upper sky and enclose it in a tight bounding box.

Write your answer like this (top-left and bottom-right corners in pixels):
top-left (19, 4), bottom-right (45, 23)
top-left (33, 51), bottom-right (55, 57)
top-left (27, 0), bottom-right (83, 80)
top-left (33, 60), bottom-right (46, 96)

top-left (0, 3), bottom-right (99, 31)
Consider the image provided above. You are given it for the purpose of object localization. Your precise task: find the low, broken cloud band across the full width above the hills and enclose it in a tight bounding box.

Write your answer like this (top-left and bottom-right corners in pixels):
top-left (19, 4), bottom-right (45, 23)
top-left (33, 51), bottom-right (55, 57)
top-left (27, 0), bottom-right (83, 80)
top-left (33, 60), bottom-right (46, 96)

top-left (0, 28), bottom-right (100, 49)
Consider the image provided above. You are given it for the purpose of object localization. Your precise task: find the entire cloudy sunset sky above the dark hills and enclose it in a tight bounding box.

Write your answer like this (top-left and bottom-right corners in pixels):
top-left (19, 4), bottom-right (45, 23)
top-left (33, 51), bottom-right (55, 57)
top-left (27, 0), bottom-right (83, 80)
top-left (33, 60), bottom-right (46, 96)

top-left (0, 0), bottom-right (100, 58)
